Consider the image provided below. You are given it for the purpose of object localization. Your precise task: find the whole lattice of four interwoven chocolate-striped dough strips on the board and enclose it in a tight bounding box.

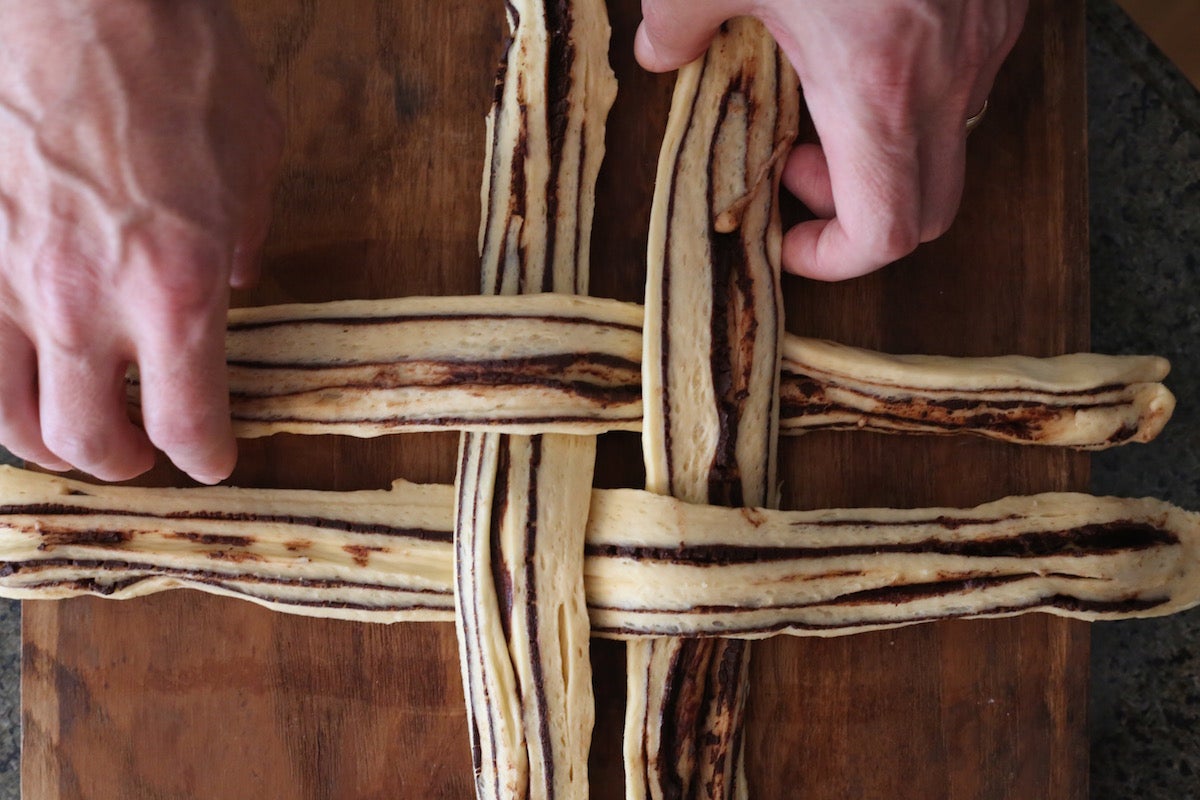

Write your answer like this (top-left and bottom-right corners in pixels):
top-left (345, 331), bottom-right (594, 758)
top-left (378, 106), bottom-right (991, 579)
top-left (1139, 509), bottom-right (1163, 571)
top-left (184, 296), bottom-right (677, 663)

top-left (0, 0), bottom-right (1200, 799)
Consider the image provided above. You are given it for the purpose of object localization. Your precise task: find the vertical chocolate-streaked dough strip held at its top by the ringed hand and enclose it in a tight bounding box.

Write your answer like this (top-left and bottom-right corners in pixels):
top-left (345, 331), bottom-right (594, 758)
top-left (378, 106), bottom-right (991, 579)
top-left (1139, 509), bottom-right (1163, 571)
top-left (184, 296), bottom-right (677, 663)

top-left (625, 19), bottom-right (799, 800)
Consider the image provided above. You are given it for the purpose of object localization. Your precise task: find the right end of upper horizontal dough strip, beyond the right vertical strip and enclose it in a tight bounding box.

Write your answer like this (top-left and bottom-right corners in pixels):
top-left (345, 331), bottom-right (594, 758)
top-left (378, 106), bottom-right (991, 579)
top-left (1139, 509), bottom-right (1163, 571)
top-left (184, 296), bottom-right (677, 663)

top-left (780, 336), bottom-right (1175, 450)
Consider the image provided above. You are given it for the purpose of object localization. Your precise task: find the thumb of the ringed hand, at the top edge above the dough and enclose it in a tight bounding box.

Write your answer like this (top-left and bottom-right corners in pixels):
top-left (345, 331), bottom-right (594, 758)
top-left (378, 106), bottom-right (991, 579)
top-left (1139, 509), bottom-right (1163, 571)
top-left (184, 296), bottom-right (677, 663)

top-left (634, 0), bottom-right (751, 72)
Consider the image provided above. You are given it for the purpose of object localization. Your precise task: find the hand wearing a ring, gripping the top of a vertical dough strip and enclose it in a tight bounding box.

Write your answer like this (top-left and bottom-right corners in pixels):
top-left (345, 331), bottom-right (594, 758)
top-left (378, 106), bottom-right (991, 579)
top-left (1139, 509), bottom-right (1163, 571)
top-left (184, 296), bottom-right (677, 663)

top-left (635, 0), bottom-right (1027, 281)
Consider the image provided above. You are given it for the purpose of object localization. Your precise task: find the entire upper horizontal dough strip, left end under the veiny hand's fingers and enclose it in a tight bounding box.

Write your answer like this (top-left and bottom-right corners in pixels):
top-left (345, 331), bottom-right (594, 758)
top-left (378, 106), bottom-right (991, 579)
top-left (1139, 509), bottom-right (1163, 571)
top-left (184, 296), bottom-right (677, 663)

top-left (121, 294), bottom-right (1175, 449)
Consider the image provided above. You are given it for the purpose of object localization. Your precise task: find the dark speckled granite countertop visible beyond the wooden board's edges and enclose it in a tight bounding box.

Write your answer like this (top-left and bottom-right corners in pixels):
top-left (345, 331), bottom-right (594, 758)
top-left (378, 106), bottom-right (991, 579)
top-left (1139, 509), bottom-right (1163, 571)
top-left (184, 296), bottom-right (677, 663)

top-left (0, 0), bottom-right (1200, 800)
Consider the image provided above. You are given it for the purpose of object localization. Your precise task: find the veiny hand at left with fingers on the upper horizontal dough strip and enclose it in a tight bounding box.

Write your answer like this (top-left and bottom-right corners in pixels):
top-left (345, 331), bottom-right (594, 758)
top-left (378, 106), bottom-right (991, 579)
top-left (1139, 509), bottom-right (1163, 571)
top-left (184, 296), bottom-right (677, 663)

top-left (0, 0), bottom-right (282, 483)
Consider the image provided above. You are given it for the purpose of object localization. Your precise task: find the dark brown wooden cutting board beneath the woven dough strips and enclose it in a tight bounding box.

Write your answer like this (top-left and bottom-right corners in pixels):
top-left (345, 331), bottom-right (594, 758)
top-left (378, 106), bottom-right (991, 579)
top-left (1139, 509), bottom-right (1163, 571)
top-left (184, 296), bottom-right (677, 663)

top-left (23, 0), bottom-right (1088, 800)
